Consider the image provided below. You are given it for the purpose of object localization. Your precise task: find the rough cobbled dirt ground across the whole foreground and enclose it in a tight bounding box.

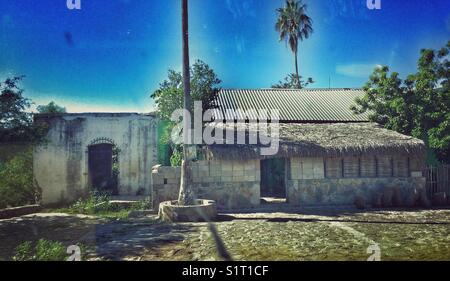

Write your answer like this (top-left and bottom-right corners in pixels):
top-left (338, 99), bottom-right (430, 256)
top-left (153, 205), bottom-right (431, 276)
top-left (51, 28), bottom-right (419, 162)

top-left (0, 208), bottom-right (450, 261)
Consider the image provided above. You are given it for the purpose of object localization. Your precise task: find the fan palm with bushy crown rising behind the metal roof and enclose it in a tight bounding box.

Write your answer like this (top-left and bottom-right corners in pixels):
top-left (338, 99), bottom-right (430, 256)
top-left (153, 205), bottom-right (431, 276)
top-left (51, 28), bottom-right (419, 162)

top-left (275, 0), bottom-right (313, 88)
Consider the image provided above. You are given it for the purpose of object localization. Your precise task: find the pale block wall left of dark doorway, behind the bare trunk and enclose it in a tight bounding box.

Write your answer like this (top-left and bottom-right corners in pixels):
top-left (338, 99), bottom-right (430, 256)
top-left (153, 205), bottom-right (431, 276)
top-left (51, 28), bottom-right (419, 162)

top-left (152, 160), bottom-right (261, 209)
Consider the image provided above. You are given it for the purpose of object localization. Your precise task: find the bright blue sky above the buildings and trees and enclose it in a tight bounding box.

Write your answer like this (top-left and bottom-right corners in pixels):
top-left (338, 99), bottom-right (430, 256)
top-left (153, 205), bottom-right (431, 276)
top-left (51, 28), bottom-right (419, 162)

top-left (0, 0), bottom-right (450, 112)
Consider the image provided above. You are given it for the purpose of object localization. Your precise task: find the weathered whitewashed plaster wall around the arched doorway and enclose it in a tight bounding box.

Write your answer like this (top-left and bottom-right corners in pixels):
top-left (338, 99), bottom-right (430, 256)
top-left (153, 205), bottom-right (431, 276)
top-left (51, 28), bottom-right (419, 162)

top-left (33, 113), bottom-right (157, 205)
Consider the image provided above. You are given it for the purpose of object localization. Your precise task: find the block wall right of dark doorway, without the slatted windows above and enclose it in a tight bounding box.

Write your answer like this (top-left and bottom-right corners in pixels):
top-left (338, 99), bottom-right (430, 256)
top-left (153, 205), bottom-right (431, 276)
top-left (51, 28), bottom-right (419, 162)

top-left (287, 156), bottom-right (425, 205)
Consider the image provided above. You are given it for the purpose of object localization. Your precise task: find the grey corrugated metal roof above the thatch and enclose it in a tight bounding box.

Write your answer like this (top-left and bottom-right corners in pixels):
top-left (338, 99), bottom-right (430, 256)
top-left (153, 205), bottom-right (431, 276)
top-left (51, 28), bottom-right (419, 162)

top-left (215, 89), bottom-right (369, 122)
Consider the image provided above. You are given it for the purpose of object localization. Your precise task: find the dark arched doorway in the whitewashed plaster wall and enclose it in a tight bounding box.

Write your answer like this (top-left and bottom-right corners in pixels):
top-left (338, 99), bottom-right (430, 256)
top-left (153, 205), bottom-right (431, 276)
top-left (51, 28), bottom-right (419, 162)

top-left (88, 139), bottom-right (119, 195)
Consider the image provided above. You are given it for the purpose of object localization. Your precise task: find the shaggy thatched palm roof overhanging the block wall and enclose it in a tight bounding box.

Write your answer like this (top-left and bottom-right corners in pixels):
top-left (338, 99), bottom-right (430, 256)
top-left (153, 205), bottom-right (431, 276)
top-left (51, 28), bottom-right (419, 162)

top-left (204, 123), bottom-right (425, 159)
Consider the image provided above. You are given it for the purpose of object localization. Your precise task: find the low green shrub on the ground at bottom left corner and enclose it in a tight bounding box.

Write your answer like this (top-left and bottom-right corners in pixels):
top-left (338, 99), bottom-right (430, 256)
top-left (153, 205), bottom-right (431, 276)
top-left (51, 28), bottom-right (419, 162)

top-left (12, 239), bottom-right (67, 261)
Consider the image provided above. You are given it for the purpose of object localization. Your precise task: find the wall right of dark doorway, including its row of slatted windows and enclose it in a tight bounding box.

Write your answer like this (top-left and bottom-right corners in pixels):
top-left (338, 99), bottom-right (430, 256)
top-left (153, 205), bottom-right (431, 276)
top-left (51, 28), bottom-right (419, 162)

top-left (286, 155), bottom-right (425, 206)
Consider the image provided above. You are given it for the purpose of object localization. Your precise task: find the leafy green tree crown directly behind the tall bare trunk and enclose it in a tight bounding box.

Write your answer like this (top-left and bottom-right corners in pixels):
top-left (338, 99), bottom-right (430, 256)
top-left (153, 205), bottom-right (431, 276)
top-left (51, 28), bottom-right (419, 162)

top-left (150, 60), bottom-right (221, 120)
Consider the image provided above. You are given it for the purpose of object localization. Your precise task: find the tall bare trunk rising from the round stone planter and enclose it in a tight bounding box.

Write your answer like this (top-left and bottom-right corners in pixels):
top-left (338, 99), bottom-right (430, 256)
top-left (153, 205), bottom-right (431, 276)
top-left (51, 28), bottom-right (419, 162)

top-left (178, 0), bottom-right (194, 206)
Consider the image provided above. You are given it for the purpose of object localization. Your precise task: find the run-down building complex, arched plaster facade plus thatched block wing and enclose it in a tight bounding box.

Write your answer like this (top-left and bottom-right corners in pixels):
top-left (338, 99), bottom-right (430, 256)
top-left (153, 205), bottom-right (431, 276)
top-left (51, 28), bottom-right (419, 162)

top-left (34, 89), bottom-right (425, 209)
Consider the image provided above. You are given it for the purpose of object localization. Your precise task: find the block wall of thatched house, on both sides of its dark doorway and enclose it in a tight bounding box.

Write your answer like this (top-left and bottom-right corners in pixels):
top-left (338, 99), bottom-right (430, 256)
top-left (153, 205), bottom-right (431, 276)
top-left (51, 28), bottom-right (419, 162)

top-left (152, 154), bottom-right (425, 209)
